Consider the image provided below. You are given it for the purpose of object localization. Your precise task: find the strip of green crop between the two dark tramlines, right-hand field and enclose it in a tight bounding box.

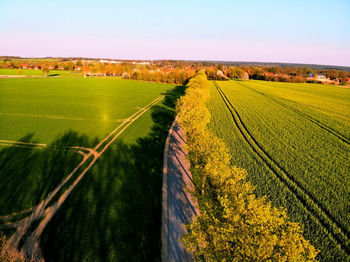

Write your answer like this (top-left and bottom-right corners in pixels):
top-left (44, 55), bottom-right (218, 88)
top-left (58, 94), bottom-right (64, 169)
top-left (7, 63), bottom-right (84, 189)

top-left (216, 82), bottom-right (350, 228)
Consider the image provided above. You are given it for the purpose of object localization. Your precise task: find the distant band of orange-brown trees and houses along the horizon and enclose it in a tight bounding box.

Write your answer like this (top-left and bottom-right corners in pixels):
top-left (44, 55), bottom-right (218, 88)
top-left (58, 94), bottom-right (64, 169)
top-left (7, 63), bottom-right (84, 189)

top-left (0, 57), bottom-right (350, 85)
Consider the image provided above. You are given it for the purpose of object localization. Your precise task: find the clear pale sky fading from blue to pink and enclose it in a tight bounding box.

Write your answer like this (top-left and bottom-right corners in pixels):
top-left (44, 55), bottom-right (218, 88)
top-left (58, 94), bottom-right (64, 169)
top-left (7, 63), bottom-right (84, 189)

top-left (0, 0), bottom-right (350, 66)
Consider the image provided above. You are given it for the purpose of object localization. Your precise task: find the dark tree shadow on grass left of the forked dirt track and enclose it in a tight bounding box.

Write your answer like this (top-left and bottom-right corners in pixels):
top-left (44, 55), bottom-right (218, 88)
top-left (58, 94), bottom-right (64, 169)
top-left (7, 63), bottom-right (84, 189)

top-left (0, 131), bottom-right (95, 216)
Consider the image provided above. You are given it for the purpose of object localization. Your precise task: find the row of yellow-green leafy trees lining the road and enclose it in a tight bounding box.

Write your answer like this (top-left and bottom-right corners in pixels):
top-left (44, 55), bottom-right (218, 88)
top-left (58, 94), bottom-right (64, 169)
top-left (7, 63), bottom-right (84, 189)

top-left (177, 72), bottom-right (319, 261)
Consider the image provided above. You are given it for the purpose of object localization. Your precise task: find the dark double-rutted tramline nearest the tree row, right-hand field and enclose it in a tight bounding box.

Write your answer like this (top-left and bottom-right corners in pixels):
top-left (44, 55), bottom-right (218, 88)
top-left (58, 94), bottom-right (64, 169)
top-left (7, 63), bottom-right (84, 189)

top-left (213, 81), bottom-right (350, 255)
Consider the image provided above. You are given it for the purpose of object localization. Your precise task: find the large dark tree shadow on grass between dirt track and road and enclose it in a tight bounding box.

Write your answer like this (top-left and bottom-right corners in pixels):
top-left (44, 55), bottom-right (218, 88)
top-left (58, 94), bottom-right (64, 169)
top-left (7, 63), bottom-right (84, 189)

top-left (0, 87), bottom-right (185, 261)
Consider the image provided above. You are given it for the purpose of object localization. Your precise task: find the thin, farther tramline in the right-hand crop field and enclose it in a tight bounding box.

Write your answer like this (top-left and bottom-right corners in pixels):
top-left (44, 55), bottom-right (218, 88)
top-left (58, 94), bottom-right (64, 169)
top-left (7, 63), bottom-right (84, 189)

top-left (238, 83), bottom-right (350, 145)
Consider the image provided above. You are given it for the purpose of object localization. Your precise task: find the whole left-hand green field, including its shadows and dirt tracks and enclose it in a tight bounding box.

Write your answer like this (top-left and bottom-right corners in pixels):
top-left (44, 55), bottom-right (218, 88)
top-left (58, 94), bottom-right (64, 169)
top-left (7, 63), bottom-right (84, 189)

top-left (0, 78), bottom-right (183, 261)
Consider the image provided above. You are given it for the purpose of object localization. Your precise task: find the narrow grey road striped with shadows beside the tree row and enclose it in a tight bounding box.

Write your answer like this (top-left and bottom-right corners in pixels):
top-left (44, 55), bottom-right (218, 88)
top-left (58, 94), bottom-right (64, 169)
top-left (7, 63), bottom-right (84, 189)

top-left (162, 120), bottom-right (199, 262)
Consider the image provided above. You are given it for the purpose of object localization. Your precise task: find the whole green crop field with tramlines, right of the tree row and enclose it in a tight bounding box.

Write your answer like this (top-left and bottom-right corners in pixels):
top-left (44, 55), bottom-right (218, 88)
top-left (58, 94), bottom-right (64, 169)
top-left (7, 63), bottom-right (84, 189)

top-left (208, 81), bottom-right (350, 261)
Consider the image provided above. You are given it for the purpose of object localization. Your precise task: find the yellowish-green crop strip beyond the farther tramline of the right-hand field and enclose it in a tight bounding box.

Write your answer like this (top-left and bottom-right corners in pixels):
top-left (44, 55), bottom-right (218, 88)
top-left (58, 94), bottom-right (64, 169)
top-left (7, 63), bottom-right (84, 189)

top-left (242, 81), bottom-right (350, 139)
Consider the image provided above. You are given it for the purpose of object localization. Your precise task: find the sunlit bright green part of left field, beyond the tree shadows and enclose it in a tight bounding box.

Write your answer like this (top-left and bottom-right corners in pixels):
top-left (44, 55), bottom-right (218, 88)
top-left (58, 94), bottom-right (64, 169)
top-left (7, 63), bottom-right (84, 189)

top-left (0, 78), bottom-right (169, 143)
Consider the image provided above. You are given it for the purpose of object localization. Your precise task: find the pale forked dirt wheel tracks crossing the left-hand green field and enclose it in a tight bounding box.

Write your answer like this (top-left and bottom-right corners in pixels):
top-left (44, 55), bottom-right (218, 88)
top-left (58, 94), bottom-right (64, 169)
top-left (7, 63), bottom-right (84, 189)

top-left (0, 95), bottom-right (164, 259)
